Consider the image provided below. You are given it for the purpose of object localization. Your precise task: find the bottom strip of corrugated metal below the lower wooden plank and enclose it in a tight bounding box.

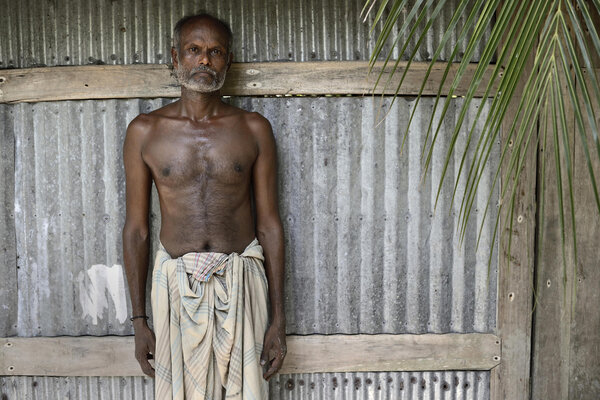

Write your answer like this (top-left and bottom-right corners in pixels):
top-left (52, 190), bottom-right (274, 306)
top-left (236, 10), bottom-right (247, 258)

top-left (0, 371), bottom-right (490, 400)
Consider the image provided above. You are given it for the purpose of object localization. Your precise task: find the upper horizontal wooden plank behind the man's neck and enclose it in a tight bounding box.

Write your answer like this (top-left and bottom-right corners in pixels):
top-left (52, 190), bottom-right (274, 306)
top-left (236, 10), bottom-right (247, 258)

top-left (0, 61), bottom-right (500, 103)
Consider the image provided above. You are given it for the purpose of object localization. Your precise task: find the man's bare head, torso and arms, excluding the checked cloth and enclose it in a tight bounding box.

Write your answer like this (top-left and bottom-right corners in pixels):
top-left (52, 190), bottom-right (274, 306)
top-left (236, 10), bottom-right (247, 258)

top-left (123, 14), bottom-right (286, 396)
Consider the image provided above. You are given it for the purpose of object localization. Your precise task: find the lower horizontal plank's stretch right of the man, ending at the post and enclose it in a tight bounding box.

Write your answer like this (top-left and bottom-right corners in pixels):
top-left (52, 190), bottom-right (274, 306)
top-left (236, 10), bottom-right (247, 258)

top-left (282, 334), bottom-right (500, 373)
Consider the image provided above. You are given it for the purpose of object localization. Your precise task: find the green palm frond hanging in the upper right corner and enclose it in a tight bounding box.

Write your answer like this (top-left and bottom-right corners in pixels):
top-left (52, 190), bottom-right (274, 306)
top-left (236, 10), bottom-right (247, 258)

top-left (363, 0), bottom-right (600, 288)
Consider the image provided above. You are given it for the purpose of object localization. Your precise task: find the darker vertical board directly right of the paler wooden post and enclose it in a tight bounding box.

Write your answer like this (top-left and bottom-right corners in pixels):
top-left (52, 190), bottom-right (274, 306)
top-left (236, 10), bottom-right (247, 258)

top-left (531, 51), bottom-right (575, 400)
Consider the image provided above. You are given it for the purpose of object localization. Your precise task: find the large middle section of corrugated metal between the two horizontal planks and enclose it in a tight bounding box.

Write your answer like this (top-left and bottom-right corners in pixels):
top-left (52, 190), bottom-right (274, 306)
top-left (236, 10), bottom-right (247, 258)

top-left (0, 97), bottom-right (497, 336)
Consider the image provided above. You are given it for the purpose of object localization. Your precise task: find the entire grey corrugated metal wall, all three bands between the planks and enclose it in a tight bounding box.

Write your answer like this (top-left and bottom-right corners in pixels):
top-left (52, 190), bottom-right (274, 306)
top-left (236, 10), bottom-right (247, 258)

top-left (0, 0), bottom-right (498, 400)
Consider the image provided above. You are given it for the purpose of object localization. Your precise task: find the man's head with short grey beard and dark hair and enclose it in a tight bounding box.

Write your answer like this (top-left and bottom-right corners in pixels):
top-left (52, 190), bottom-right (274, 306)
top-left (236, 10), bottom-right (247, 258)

top-left (171, 18), bottom-right (231, 93)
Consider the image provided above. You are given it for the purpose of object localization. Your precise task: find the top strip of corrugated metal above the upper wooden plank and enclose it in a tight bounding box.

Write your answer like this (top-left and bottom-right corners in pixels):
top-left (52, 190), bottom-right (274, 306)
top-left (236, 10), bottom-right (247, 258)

top-left (0, 0), bottom-right (485, 68)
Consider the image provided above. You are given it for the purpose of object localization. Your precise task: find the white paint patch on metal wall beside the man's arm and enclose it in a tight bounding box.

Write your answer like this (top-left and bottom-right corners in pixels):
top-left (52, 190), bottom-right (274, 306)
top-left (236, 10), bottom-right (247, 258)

top-left (77, 264), bottom-right (127, 325)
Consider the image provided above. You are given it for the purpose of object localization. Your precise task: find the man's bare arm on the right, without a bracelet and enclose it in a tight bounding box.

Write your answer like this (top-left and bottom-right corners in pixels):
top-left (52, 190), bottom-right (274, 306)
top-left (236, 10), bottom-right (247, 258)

top-left (250, 114), bottom-right (287, 379)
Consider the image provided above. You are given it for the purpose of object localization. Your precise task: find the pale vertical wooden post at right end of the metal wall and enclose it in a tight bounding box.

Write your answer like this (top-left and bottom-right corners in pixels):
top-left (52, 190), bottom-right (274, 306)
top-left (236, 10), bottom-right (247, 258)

top-left (490, 7), bottom-right (536, 400)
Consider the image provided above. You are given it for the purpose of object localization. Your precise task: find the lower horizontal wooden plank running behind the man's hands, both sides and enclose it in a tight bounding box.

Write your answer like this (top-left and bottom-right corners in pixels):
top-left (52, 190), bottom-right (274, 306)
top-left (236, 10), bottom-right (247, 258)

top-left (0, 334), bottom-right (501, 376)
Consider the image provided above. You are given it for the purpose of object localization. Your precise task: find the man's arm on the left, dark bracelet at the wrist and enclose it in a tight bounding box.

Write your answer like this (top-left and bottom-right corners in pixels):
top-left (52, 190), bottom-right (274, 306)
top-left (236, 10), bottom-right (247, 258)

top-left (123, 116), bottom-right (155, 377)
